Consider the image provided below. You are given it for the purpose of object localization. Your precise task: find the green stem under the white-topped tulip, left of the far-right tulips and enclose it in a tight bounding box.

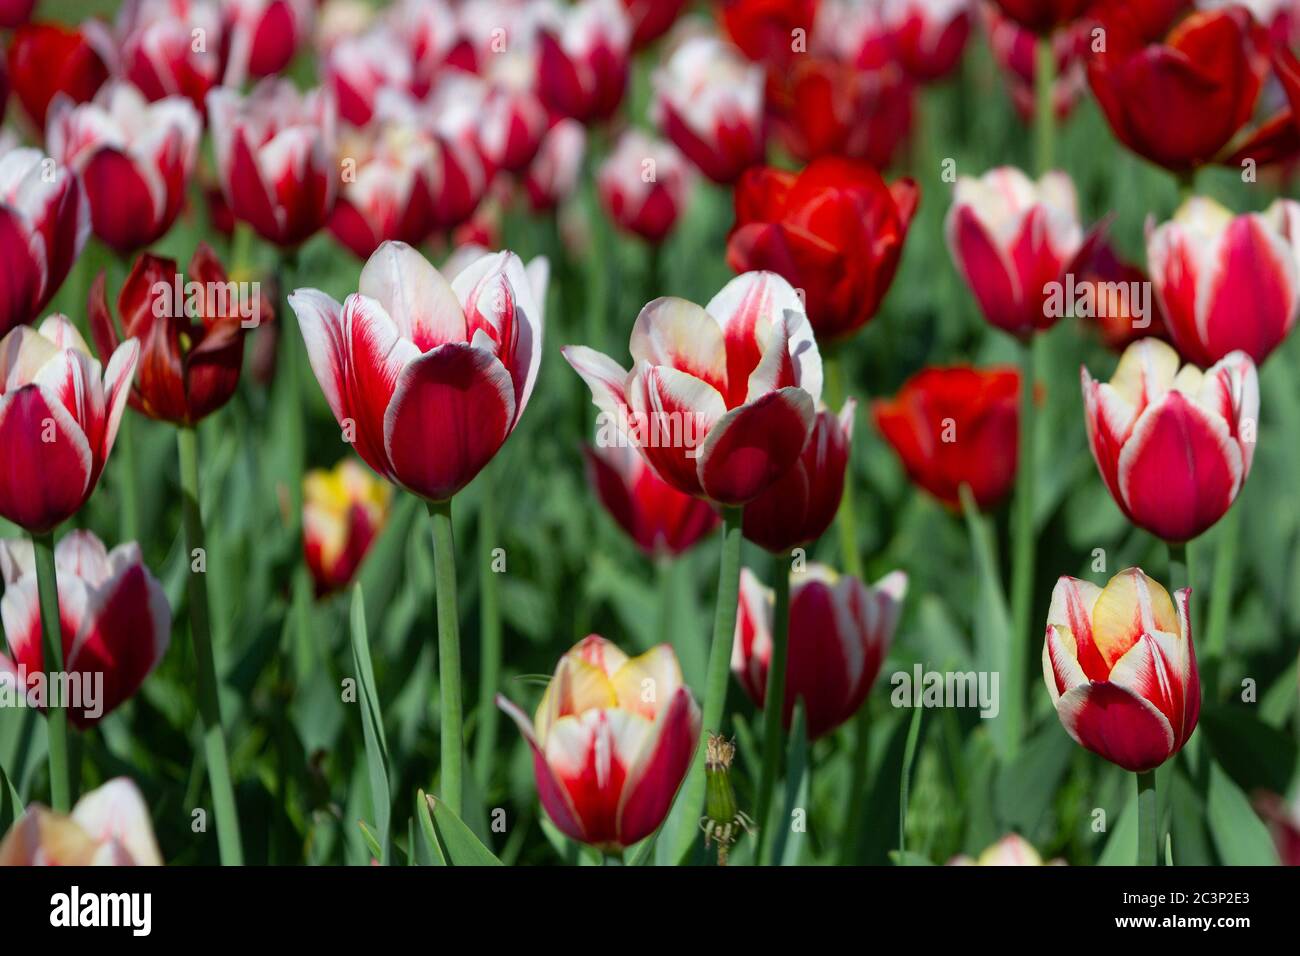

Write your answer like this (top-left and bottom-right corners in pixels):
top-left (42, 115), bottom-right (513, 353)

top-left (1008, 336), bottom-right (1039, 753)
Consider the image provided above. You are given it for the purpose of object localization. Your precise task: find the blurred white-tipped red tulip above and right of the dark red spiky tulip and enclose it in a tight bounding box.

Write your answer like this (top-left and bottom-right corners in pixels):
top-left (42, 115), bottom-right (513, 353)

top-left (208, 78), bottom-right (338, 247)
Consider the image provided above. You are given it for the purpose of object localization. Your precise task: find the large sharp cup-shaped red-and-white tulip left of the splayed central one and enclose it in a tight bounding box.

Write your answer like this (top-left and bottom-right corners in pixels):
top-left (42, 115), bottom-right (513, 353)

top-left (289, 242), bottom-right (546, 501)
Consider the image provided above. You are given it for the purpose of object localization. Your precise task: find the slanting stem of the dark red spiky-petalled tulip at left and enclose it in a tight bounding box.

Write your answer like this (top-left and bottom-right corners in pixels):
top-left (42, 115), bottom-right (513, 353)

top-left (176, 428), bottom-right (243, 866)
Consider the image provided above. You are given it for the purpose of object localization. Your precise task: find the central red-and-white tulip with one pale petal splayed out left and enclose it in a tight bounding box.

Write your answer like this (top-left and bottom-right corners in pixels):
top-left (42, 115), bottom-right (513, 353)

top-left (562, 272), bottom-right (822, 505)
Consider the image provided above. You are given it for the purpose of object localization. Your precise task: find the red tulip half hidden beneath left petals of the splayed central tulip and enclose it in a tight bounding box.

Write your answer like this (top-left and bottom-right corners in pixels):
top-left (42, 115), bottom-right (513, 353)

top-left (584, 444), bottom-right (718, 558)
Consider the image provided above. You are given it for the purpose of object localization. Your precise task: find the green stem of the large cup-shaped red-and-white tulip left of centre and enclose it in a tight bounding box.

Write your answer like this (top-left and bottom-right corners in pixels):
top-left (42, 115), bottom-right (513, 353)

top-left (429, 498), bottom-right (464, 817)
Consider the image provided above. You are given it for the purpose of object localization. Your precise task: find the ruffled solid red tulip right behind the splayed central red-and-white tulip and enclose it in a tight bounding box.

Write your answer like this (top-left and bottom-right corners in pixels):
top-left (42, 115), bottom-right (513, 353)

top-left (727, 157), bottom-right (919, 343)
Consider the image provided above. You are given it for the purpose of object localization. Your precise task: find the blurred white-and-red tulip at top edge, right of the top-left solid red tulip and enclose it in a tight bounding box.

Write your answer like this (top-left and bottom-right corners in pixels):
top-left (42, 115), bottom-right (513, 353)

top-left (116, 0), bottom-right (221, 113)
